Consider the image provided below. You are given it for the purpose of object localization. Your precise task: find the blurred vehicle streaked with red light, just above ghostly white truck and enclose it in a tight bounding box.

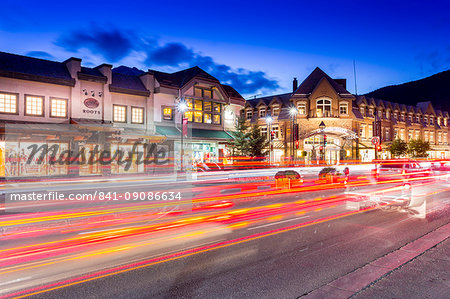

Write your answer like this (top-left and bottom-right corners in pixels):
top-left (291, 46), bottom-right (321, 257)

top-left (372, 159), bottom-right (432, 183)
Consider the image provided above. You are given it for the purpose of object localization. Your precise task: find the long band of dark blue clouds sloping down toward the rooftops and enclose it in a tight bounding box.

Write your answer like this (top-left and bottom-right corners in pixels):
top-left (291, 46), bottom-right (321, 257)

top-left (56, 26), bottom-right (280, 94)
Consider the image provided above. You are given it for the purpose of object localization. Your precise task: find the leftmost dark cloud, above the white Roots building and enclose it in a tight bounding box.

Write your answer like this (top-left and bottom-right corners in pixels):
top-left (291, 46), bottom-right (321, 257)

top-left (56, 26), bottom-right (135, 63)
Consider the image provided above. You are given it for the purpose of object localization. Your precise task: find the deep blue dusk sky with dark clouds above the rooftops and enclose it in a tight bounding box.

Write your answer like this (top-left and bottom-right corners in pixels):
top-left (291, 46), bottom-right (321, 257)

top-left (0, 0), bottom-right (450, 97)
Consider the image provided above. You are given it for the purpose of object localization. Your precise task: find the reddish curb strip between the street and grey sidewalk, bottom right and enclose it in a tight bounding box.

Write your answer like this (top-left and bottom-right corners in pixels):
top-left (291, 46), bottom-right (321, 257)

top-left (300, 223), bottom-right (450, 299)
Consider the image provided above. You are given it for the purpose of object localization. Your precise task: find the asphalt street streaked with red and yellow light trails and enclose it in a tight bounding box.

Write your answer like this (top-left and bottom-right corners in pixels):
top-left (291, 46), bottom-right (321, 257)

top-left (0, 169), bottom-right (450, 298)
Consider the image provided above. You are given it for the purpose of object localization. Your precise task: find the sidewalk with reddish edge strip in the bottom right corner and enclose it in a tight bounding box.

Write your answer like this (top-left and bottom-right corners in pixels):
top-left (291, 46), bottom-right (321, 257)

top-left (301, 224), bottom-right (450, 299)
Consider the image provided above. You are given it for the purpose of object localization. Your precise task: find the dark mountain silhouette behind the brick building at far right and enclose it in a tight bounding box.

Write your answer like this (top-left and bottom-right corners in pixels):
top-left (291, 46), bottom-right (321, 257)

top-left (365, 70), bottom-right (450, 112)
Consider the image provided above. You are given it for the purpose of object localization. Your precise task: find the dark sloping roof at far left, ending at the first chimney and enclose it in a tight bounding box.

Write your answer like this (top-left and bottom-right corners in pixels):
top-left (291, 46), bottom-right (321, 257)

top-left (0, 52), bottom-right (75, 86)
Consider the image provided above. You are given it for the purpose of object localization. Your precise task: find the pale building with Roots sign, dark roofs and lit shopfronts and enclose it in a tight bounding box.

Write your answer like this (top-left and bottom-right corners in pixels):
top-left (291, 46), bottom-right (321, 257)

top-left (0, 52), bottom-right (245, 177)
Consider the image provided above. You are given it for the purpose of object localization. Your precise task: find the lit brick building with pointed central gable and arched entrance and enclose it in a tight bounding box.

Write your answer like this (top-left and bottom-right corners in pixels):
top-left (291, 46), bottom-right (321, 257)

top-left (243, 68), bottom-right (450, 163)
